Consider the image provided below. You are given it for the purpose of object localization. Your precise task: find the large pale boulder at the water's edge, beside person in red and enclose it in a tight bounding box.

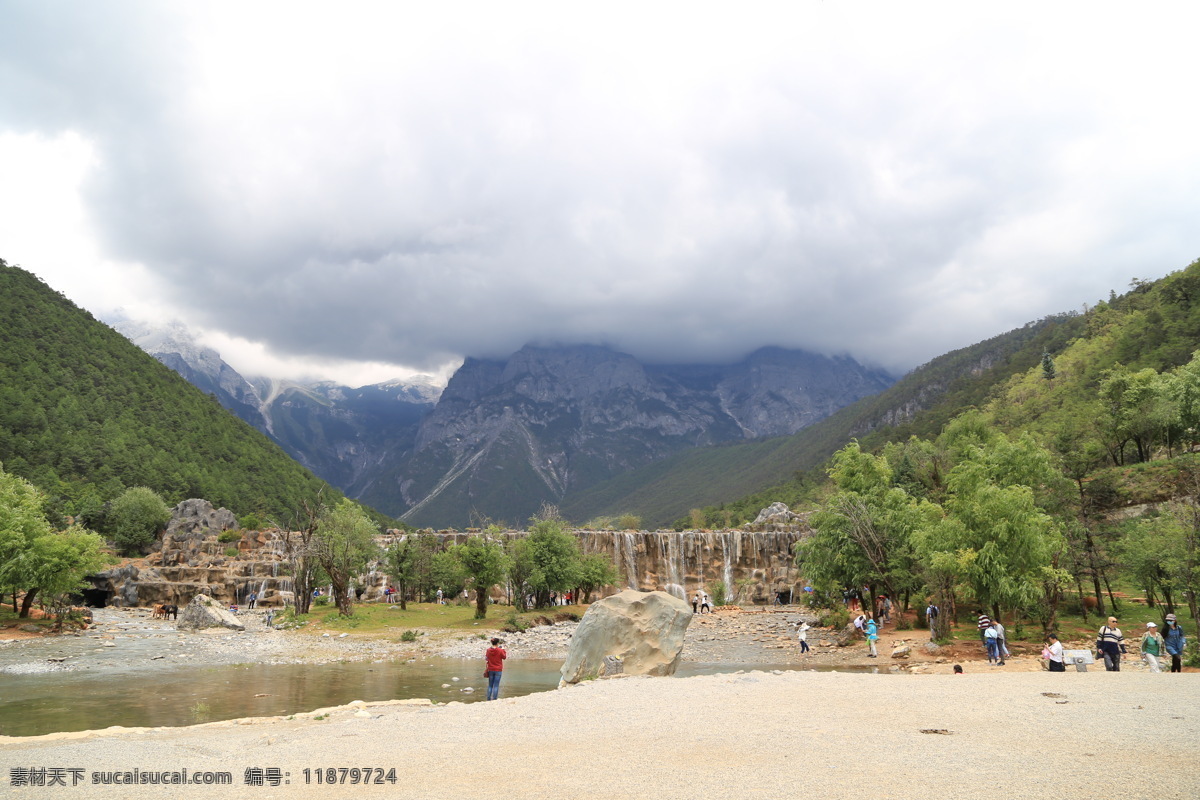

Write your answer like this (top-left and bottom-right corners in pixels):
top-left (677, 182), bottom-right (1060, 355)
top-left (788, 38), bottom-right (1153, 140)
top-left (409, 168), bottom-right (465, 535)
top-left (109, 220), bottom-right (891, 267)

top-left (558, 589), bottom-right (691, 686)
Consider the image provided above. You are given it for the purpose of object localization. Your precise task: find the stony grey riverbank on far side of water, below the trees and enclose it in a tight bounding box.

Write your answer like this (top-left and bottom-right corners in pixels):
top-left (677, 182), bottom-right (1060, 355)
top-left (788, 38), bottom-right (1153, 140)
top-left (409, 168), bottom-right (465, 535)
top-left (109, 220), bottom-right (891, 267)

top-left (0, 607), bottom-right (1180, 674)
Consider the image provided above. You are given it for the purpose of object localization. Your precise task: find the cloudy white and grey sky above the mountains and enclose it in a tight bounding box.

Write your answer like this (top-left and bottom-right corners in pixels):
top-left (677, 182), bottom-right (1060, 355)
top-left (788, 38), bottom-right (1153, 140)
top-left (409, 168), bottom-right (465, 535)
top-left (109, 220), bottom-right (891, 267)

top-left (0, 0), bottom-right (1200, 385)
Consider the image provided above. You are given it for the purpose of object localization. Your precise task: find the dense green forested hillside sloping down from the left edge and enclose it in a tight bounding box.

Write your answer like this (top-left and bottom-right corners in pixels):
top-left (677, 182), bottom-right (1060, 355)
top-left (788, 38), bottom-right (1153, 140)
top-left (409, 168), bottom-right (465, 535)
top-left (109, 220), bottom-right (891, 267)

top-left (0, 260), bottom-right (341, 521)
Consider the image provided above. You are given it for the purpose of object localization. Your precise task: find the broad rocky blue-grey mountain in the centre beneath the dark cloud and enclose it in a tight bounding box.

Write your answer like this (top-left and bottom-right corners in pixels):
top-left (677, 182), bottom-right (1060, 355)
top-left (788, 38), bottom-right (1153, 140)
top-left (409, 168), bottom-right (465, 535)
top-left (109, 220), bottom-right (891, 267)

top-left (362, 345), bottom-right (892, 525)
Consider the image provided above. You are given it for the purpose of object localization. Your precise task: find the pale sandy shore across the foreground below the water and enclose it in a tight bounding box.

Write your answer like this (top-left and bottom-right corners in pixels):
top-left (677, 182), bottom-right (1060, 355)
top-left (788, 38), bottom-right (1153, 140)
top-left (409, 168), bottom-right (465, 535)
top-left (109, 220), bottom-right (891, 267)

top-left (0, 670), bottom-right (1200, 800)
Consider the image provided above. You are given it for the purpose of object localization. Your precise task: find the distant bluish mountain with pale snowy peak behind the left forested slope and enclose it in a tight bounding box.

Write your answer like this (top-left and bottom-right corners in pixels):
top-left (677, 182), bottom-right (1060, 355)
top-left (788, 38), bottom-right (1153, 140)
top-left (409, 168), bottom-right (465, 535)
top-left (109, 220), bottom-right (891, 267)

top-left (114, 320), bottom-right (440, 498)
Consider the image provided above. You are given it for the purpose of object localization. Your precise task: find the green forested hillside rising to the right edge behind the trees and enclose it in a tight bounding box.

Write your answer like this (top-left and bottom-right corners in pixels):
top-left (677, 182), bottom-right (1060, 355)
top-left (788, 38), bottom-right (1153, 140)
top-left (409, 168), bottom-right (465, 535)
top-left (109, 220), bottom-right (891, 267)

top-left (667, 261), bottom-right (1200, 525)
